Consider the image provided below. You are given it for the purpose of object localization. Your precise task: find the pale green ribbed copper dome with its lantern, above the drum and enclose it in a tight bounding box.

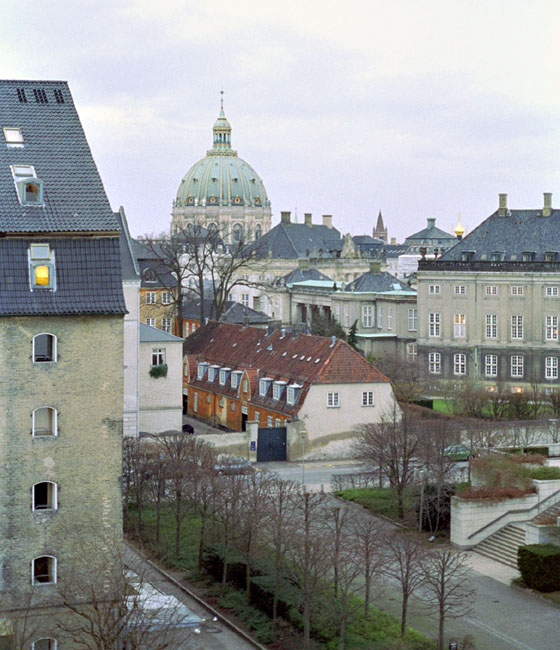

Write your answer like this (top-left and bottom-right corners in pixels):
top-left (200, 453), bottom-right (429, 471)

top-left (175, 106), bottom-right (270, 207)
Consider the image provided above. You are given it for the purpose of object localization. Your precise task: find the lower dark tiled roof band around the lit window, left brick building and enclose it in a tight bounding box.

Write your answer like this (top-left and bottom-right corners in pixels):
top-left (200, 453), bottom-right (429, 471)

top-left (0, 237), bottom-right (126, 316)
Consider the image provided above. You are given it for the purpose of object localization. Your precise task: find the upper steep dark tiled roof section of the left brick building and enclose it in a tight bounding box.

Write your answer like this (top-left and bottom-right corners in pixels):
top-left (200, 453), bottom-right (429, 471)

top-left (0, 80), bottom-right (118, 233)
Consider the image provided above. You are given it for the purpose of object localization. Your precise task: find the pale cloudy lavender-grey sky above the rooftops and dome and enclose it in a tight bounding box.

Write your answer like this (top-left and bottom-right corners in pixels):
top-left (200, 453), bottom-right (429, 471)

top-left (0, 0), bottom-right (560, 242)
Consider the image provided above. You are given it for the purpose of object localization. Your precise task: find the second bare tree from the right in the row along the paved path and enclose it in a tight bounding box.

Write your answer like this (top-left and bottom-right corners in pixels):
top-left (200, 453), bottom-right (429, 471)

top-left (383, 533), bottom-right (424, 636)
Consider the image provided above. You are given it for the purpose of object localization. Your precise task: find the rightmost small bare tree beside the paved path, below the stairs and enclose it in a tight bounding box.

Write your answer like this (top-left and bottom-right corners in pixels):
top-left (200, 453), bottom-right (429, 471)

top-left (418, 550), bottom-right (476, 650)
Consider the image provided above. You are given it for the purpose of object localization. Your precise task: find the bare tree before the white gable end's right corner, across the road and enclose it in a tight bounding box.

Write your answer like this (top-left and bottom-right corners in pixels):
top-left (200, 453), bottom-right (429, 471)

top-left (354, 404), bottom-right (423, 519)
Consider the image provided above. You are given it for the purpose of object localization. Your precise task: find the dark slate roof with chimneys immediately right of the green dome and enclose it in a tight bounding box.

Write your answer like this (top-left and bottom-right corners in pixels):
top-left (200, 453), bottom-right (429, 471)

top-left (250, 223), bottom-right (344, 259)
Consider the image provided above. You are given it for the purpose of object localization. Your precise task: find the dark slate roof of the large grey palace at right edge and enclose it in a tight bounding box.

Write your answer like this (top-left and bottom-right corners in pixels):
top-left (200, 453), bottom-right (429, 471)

top-left (438, 209), bottom-right (560, 262)
